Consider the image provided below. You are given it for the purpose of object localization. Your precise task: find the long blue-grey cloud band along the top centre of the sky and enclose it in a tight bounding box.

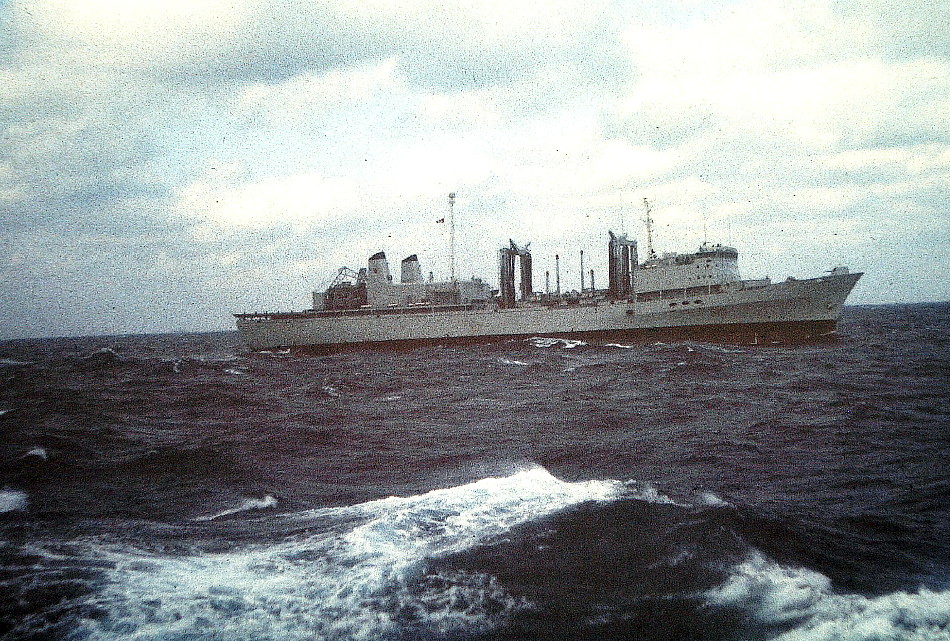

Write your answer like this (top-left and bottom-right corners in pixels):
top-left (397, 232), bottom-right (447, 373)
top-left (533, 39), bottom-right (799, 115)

top-left (143, 2), bottom-right (629, 92)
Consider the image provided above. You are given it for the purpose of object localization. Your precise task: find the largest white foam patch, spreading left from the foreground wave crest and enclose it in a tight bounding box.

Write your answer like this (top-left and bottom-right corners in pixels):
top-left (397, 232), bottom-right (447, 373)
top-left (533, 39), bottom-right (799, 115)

top-left (69, 468), bottom-right (624, 639)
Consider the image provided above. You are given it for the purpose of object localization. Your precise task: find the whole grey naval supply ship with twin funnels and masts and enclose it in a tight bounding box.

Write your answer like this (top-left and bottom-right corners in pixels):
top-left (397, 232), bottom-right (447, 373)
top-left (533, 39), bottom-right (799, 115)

top-left (234, 199), bottom-right (862, 352)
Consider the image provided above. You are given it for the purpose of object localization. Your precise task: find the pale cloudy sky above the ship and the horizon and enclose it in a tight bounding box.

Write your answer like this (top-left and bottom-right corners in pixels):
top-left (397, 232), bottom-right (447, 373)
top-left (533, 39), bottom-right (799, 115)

top-left (0, 0), bottom-right (950, 338)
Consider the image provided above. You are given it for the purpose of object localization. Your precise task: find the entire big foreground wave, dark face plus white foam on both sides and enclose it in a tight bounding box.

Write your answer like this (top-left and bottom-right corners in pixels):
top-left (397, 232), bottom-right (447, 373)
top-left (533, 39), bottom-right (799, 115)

top-left (18, 467), bottom-right (950, 641)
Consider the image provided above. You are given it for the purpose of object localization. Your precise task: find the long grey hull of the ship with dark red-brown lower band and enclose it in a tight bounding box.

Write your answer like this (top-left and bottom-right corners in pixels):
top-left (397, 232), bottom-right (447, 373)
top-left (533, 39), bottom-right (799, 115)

top-left (237, 274), bottom-right (861, 351)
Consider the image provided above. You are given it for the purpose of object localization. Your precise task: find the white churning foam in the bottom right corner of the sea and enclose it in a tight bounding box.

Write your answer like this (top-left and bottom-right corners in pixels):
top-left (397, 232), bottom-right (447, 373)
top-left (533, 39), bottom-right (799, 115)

top-left (705, 554), bottom-right (950, 641)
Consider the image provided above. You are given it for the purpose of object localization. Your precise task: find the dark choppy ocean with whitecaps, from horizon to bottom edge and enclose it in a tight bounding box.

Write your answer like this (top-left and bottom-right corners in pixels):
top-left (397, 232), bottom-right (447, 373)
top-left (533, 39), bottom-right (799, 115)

top-left (0, 304), bottom-right (950, 641)
